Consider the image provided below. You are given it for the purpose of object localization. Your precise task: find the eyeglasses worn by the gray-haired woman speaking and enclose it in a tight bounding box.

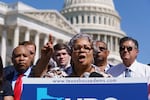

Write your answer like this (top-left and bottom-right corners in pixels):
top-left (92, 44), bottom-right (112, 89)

top-left (72, 45), bottom-right (93, 52)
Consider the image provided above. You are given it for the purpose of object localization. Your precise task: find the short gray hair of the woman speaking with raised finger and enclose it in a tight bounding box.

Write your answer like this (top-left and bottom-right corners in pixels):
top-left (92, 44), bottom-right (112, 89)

top-left (68, 33), bottom-right (93, 50)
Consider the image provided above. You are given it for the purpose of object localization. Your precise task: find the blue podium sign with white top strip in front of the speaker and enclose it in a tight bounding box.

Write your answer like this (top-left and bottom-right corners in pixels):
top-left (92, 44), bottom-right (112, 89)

top-left (21, 78), bottom-right (148, 100)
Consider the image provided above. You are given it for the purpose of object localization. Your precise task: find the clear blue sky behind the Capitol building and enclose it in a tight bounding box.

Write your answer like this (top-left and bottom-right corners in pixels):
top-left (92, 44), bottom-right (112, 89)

top-left (0, 0), bottom-right (150, 64)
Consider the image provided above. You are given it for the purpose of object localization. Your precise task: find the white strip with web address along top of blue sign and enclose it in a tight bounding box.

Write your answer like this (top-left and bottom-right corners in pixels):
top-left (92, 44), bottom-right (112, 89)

top-left (23, 78), bottom-right (148, 84)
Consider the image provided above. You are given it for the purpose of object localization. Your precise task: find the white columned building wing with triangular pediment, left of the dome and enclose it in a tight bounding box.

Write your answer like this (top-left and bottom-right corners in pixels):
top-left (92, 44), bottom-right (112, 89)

top-left (0, 2), bottom-right (79, 65)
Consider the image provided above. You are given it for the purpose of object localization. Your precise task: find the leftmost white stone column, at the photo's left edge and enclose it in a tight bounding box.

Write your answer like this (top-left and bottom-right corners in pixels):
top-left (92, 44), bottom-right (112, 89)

top-left (1, 27), bottom-right (7, 67)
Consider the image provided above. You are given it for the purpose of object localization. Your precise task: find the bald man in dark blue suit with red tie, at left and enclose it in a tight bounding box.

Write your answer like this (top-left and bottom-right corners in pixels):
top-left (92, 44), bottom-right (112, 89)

top-left (4, 45), bottom-right (32, 87)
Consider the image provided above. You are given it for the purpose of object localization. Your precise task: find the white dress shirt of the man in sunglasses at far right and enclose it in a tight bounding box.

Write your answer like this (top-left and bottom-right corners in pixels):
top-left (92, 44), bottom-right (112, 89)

top-left (107, 60), bottom-right (150, 78)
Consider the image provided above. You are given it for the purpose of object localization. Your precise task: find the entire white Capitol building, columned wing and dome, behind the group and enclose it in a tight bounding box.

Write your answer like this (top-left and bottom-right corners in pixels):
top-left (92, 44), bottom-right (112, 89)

top-left (0, 0), bottom-right (126, 66)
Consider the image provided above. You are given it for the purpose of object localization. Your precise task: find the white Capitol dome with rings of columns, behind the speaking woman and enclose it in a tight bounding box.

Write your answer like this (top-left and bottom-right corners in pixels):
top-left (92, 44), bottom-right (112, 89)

top-left (61, 0), bottom-right (126, 65)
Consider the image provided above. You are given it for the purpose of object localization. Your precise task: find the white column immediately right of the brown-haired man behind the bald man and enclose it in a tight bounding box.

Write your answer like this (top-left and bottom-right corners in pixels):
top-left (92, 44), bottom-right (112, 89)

top-left (34, 32), bottom-right (40, 62)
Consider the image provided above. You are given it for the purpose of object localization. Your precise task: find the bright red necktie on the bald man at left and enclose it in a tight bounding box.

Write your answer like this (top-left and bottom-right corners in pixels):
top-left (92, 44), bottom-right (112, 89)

top-left (14, 74), bottom-right (23, 100)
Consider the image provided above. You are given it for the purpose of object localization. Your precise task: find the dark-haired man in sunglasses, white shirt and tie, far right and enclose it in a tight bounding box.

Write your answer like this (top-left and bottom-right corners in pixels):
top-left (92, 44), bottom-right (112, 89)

top-left (108, 37), bottom-right (150, 77)
